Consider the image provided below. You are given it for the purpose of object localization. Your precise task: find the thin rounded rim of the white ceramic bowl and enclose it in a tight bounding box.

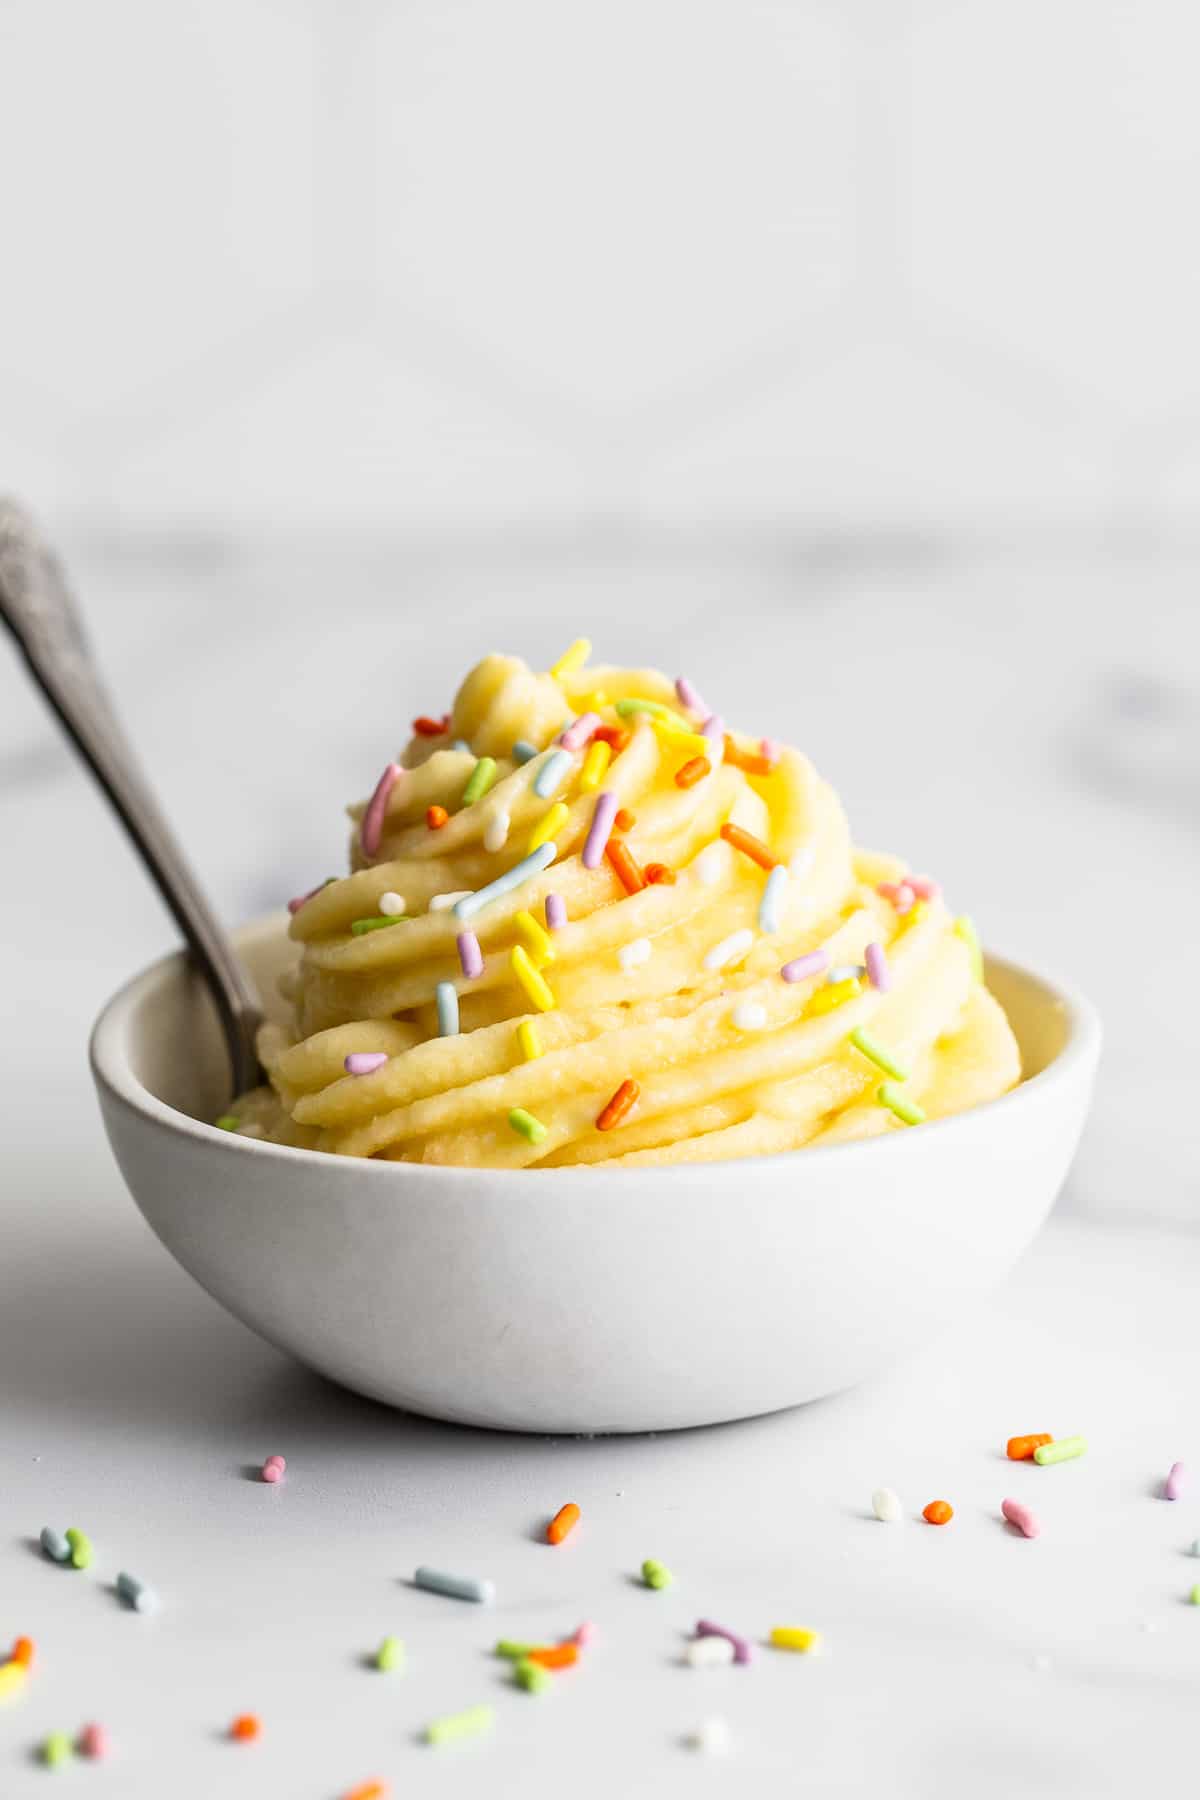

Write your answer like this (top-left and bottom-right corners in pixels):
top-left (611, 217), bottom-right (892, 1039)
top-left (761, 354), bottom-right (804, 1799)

top-left (88, 913), bottom-right (1103, 1186)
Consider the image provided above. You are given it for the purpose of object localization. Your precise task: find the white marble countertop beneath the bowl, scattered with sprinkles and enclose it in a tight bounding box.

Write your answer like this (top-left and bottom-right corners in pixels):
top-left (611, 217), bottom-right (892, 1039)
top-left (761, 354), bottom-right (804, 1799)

top-left (0, 540), bottom-right (1200, 1800)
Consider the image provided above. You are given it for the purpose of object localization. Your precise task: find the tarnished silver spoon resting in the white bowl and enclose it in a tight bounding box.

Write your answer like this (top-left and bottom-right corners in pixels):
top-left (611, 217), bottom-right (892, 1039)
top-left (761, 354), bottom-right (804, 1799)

top-left (0, 499), bottom-right (263, 1094)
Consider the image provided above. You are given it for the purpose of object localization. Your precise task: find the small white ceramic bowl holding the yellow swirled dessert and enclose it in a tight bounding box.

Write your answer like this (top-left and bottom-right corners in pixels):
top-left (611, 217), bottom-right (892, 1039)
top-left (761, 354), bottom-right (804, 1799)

top-left (92, 916), bottom-right (1101, 1431)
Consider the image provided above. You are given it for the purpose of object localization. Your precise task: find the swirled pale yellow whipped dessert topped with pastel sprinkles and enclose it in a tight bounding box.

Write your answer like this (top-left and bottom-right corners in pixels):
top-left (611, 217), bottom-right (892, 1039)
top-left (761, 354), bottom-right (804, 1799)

top-left (236, 655), bottom-right (1020, 1168)
